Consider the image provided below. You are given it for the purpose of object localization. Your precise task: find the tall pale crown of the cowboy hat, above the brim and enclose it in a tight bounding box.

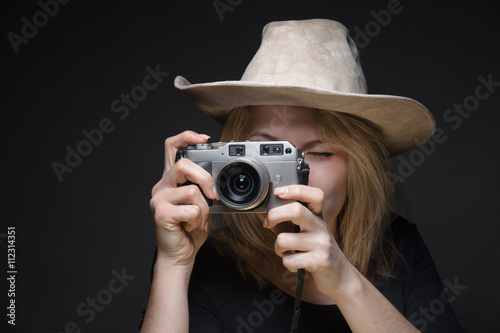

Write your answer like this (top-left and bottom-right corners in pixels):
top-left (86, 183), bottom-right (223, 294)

top-left (241, 19), bottom-right (367, 94)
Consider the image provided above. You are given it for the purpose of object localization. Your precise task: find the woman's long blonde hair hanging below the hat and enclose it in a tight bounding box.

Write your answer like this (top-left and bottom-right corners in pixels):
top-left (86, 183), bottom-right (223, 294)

top-left (217, 107), bottom-right (398, 287)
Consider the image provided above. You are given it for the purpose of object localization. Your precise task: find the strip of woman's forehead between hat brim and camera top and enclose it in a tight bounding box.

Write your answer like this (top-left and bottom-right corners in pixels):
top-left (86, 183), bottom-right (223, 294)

top-left (249, 105), bottom-right (316, 138)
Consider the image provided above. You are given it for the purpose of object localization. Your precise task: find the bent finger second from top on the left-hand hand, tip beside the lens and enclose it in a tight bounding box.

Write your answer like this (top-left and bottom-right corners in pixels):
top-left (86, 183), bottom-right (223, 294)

top-left (163, 158), bottom-right (219, 199)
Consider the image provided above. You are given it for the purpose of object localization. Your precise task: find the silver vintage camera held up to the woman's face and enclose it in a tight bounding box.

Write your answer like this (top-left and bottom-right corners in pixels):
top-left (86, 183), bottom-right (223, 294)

top-left (177, 141), bottom-right (309, 214)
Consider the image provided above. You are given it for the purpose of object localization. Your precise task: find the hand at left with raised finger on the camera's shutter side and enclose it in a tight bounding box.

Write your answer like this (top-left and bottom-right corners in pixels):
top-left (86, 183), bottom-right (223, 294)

top-left (150, 131), bottom-right (218, 268)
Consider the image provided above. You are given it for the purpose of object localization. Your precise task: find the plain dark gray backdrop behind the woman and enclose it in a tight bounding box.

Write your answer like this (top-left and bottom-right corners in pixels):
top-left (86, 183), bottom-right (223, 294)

top-left (0, 0), bottom-right (500, 332)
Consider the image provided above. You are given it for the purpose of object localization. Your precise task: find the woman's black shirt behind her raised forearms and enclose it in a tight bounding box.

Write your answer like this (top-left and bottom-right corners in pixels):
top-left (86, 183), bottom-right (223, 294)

top-left (189, 217), bottom-right (463, 333)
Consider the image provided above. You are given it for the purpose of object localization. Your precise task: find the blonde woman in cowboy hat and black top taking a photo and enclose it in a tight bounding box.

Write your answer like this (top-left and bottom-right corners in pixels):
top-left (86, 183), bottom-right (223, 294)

top-left (142, 20), bottom-right (461, 332)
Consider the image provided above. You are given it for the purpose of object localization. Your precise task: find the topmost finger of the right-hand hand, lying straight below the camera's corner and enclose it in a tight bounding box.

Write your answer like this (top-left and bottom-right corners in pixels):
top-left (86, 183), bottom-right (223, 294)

top-left (274, 185), bottom-right (325, 215)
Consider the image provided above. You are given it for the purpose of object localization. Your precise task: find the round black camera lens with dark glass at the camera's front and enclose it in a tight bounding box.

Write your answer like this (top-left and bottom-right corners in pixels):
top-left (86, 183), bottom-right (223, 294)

top-left (216, 158), bottom-right (269, 210)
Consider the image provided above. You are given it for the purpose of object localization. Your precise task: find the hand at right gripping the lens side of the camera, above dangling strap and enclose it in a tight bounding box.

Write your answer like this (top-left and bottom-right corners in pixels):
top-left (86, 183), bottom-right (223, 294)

top-left (264, 185), bottom-right (354, 300)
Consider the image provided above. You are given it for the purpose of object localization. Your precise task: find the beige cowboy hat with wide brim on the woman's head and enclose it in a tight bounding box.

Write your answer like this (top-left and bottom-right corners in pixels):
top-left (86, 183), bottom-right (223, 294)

top-left (174, 19), bottom-right (435, 156)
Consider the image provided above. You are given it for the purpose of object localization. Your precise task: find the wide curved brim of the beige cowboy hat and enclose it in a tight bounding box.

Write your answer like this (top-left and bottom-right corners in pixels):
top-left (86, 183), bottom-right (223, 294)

top-left (174, 76), bottom-right (436, 156)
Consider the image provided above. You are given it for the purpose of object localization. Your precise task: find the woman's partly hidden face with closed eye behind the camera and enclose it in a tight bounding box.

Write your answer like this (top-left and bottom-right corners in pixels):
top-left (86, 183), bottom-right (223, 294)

top-left (247, 105), bottom-right (348, 232)
